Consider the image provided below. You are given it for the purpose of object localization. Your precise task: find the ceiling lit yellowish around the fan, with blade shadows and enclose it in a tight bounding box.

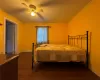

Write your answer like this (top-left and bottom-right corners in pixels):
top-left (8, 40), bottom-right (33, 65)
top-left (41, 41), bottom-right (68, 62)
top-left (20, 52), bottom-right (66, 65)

top-left (0, 0), bottom-right (91, 22)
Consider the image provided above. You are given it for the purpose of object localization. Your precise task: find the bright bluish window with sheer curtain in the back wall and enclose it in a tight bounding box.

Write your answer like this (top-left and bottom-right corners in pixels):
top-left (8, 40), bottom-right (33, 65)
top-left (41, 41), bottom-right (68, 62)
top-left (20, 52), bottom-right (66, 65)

top-left (37, 27), bottom-right (48, 44)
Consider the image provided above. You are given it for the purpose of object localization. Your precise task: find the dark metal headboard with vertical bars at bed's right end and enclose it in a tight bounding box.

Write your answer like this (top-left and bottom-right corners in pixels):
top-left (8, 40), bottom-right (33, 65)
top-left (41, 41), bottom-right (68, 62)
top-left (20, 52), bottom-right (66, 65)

top-left (68, 31), bottom-right (89, 67)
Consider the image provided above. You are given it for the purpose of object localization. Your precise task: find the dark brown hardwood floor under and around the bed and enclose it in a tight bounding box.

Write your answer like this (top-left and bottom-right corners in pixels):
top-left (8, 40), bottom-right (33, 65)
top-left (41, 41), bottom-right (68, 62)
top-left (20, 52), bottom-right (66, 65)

top-left (18, 53), bottom-right (100, 80)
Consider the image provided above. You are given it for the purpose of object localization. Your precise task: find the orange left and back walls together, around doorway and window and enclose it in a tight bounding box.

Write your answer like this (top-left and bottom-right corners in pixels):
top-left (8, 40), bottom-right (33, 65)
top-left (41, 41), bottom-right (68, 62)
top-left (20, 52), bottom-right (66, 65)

top-left (0, 10), bottom-right (67, 53)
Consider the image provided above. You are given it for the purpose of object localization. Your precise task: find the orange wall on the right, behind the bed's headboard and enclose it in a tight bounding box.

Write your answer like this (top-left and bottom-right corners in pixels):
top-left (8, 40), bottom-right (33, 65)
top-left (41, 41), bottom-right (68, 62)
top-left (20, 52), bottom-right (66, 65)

top-left (68, 0), bottom-right (100, 76)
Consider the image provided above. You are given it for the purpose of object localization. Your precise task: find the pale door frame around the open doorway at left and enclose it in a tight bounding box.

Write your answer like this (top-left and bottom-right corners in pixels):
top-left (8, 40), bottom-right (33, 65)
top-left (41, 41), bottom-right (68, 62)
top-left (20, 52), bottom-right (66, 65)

top-left (4, 17), bottom-right (18, 54)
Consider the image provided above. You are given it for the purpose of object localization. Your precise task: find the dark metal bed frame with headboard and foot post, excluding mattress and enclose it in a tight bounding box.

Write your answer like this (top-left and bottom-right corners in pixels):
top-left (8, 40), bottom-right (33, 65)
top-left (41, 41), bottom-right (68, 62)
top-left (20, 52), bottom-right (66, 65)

top-left (32, 31), bottom-right (89, 69)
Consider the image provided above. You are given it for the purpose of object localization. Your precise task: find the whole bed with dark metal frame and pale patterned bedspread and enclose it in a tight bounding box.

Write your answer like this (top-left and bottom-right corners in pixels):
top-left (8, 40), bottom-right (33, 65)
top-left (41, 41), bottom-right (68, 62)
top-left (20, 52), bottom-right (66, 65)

top-left (32, 31), bottom-right (88, 68)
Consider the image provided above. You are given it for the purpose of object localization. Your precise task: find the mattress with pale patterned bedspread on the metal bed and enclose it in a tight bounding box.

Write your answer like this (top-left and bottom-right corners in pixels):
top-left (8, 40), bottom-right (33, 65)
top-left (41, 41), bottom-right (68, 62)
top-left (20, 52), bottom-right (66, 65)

top-left (35, 44), bottom-right (86, 62)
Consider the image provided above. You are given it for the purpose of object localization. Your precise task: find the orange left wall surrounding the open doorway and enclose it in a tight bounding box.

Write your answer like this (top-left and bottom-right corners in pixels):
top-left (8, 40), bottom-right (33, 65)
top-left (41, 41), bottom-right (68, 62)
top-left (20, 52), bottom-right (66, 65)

top-left (0, 9), bottom-right (23, 53)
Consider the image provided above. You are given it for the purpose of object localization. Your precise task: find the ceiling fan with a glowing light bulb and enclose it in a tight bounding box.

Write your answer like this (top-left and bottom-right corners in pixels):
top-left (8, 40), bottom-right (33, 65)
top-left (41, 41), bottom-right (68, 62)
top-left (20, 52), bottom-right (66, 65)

top-left (21, 0), bottom-right (44, 20)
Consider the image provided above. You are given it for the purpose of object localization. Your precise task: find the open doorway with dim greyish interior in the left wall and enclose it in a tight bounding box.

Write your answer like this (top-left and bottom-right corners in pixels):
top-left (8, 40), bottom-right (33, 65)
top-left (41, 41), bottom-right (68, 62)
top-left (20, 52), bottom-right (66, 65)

top-left (5, 20), bottom-right (16, 55)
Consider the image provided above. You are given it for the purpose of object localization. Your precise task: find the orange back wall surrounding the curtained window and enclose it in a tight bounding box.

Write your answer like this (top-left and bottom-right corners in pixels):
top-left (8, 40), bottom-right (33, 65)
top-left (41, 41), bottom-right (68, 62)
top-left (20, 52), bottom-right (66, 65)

top-left (21, 23), bottom-right (67, 52)
